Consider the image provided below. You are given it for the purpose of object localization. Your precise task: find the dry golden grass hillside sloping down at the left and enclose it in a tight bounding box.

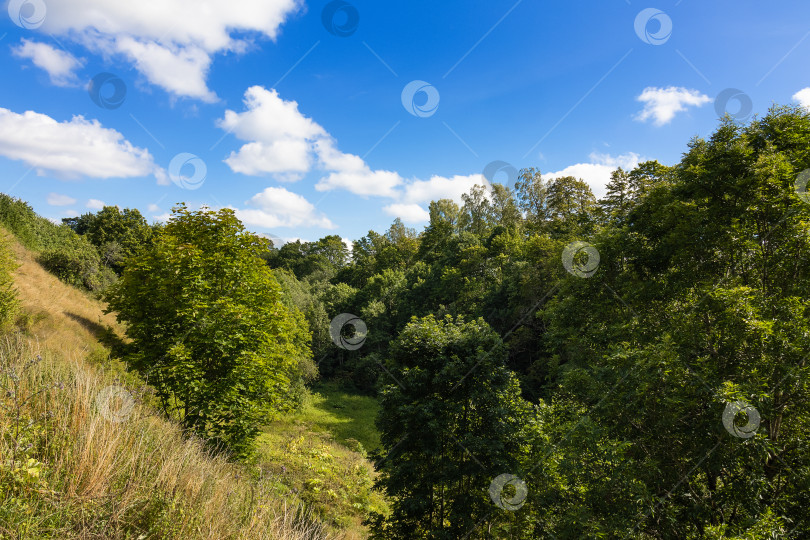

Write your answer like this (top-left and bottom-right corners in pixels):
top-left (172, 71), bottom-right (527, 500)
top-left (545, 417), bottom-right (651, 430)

top-left (0, 233), bottom-right (345, 539)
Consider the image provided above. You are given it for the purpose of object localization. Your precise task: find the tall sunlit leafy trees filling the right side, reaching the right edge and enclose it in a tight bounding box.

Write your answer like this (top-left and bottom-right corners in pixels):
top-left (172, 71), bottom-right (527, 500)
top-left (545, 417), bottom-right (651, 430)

top-left (535, 104), bottom-right (810, 538)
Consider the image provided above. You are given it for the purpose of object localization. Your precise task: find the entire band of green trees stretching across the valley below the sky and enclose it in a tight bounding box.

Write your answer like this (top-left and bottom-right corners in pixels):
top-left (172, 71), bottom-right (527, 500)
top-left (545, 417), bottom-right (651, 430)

top-left (0, 107), bottom-right (810, 539)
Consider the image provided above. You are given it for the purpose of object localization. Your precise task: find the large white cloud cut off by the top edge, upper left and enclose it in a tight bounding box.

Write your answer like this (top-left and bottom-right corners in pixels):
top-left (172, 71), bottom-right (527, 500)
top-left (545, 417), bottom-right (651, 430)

top-left (32, 0), bottom-right (303, 102)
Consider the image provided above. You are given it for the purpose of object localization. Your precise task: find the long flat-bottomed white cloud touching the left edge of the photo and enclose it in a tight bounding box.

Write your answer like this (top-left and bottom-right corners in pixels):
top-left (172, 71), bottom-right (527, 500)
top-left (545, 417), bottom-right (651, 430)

top-left (0, 108), bottom-right (161, 178)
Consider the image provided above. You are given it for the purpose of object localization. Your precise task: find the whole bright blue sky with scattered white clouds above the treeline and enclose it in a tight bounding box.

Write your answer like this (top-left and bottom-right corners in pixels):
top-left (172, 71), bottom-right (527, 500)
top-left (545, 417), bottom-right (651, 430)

top-left (0, 0), bottom-right (810, 245)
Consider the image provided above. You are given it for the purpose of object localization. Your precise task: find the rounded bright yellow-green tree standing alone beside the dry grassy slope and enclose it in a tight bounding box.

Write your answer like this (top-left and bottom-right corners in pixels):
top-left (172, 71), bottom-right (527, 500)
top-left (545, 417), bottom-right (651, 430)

top-left (107, 206), bottom-right (311, 454)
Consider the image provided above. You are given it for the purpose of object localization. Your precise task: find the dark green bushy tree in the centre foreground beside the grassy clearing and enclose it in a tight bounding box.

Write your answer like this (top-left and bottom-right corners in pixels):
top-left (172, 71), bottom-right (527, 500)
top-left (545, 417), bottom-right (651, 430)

top-left (372, 315), bottom-right (536, 539)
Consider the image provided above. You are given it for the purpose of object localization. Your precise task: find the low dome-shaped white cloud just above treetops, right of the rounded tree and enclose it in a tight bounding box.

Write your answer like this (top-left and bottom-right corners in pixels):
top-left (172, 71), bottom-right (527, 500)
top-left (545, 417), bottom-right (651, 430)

top-left (234, 187), bottom-right (336, 229)
